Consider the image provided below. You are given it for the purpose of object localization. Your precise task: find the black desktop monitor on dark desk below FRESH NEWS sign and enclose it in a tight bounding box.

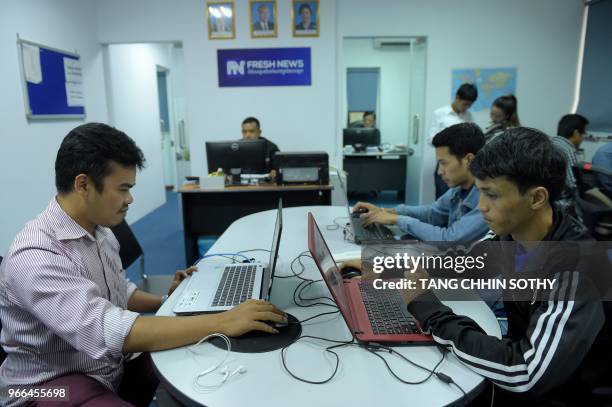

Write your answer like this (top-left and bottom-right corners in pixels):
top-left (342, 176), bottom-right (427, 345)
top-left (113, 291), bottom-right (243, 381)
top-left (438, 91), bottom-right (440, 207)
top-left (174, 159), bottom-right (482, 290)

top-left (206, 140), bottom-right (267, 174)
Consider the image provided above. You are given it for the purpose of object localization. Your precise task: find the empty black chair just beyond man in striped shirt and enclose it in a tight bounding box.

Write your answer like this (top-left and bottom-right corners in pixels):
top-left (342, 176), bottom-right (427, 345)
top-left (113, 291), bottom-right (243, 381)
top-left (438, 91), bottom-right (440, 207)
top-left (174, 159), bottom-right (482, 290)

top-left (111, 220), bottom-right (174, 295)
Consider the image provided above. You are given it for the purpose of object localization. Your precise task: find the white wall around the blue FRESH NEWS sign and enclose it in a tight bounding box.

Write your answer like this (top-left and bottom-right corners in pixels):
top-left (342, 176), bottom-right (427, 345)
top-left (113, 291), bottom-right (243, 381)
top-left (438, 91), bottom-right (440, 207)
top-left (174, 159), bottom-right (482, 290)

top-left (98, 0), bottom-right (337, 178)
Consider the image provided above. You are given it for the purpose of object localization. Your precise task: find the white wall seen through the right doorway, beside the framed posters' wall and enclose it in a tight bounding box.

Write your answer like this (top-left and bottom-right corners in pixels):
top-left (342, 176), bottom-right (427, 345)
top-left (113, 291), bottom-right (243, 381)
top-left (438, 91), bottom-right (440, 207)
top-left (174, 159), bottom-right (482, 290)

top-left (341, 38), bottom-right (410, 144)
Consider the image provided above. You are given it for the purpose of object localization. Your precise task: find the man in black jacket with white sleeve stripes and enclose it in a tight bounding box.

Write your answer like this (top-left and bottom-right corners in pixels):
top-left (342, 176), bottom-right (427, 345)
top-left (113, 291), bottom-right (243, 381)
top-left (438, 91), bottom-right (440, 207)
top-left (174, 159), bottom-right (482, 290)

top-left (404, 128), bottom-right (612, 405)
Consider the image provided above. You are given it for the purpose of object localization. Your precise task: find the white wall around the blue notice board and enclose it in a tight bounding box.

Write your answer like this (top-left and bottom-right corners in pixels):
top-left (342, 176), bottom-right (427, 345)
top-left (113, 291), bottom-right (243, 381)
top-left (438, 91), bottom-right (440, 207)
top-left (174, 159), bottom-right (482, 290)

top-left (0, 0), bottom-right (107, 255)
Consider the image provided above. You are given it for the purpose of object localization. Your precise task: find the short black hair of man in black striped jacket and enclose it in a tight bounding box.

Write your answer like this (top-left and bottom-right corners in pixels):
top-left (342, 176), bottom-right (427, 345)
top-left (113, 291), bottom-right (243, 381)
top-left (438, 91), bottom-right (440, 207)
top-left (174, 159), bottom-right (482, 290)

top-left (470, 127), bottom-right (567, 202)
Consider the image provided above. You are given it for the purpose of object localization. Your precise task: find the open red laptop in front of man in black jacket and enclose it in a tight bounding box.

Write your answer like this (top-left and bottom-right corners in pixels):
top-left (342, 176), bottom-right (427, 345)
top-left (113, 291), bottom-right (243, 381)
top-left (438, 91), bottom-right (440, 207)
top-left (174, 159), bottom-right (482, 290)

top-left (308, 213), bottom-right (434, 345)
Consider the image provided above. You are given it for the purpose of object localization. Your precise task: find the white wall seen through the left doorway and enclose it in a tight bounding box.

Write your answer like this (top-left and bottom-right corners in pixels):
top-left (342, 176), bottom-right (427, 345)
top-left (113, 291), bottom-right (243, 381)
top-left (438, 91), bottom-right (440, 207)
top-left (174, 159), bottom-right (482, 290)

top-left (104, 43), bottom-right (172, 222)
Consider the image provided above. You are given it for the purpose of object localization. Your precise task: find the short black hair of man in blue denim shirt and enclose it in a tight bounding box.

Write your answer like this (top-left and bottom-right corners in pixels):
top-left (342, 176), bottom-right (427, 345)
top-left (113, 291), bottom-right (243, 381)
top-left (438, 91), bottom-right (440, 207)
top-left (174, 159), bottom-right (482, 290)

top-left (431, 123), bottom-right (485, 160)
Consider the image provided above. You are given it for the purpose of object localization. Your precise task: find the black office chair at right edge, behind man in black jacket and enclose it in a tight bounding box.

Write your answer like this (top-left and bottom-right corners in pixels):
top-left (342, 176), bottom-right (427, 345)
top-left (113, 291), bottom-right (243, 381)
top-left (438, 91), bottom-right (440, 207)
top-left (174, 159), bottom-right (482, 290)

top-left (572, 163), bottom-right (612, 240)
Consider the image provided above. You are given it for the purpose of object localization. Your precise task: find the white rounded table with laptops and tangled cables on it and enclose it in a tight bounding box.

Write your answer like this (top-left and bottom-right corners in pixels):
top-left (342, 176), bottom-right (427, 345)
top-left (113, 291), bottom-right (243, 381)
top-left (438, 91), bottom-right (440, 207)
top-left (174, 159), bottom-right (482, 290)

top-left (152, 206), bottom-right (500, 407)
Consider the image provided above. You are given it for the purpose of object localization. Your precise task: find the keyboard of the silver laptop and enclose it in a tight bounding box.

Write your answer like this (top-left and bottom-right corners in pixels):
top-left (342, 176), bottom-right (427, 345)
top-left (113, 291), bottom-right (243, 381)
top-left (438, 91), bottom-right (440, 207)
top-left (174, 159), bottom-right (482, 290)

top-left (212, 264), bottom-right (257, 307)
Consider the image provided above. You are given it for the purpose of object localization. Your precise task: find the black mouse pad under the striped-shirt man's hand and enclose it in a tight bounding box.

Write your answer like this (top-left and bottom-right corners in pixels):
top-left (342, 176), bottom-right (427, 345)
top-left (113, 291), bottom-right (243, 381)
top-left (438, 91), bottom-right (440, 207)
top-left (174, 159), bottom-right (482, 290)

top-left (210, 314), bottom-right (302, 353)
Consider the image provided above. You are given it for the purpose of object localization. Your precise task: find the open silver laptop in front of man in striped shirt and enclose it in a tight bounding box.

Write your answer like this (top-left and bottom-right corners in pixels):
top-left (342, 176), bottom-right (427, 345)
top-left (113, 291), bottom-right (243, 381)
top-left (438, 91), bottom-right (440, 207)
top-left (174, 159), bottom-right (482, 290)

top-left (172, 199), bottom-right (283, 315)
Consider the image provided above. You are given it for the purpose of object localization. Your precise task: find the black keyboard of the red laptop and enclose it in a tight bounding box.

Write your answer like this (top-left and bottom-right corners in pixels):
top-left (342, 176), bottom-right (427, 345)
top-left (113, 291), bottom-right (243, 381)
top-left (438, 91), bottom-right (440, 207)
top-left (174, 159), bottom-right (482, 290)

top-left (359, 281), bottom-right (422, 335)
